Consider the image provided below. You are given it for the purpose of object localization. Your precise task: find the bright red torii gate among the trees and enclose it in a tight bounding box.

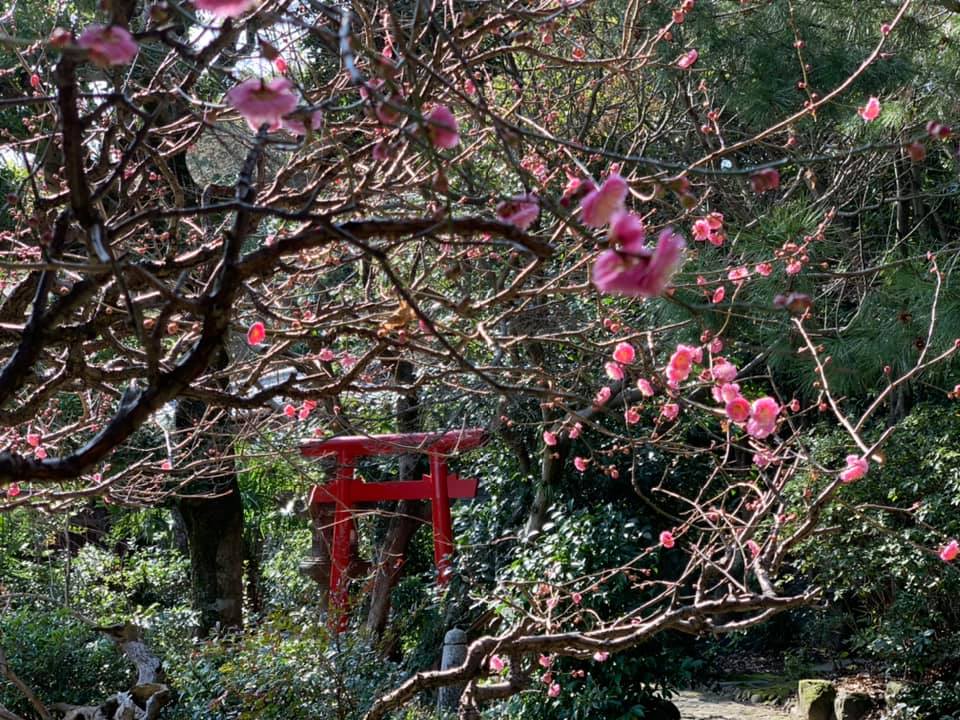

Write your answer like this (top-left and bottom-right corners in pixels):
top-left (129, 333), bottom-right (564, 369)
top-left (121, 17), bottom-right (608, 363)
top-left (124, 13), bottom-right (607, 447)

top-left (300, 428), bottom-right (487, 630)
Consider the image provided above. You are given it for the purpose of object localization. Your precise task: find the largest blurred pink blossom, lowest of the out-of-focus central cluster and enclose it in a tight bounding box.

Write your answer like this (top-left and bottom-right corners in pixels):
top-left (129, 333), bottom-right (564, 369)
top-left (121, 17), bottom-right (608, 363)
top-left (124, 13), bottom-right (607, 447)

top-left (593, 222), bottom-right (686, 297)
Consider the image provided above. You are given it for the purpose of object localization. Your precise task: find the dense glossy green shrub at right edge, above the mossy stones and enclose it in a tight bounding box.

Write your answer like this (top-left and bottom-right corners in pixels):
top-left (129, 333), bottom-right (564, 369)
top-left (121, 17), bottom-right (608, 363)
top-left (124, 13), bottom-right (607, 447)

top-left (800, 404), bottom-right (960, 676)
